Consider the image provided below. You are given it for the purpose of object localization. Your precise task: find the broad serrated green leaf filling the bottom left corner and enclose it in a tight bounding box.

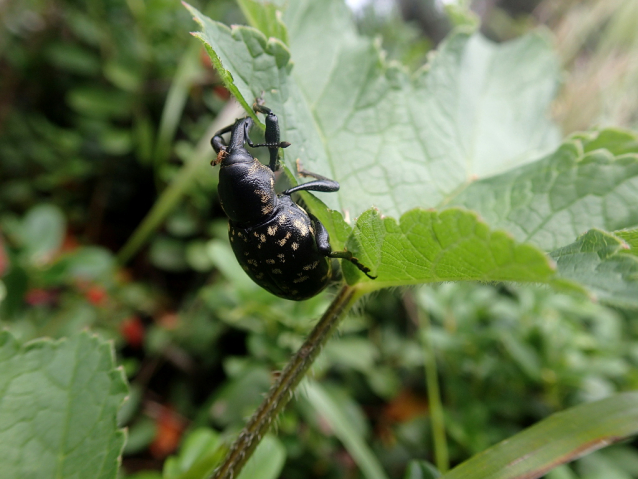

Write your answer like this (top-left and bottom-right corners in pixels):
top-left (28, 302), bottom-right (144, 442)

top-left (0, 332), bottom-right (127, 479)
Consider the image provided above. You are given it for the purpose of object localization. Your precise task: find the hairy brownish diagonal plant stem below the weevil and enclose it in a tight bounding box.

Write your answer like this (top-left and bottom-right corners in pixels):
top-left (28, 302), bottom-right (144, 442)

top-left (212, 285), bottom-right (363, 479)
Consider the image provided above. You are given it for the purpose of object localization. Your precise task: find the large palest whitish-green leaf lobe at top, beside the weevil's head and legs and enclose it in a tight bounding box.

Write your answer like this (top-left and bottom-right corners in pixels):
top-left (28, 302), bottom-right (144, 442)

top-left (184, 0), bottom-right (558, 217)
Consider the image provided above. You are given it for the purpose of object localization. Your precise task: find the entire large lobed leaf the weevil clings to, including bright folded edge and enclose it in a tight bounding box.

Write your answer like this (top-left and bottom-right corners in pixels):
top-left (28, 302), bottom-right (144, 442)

top-left (189, 0), bottom-right (638, 306)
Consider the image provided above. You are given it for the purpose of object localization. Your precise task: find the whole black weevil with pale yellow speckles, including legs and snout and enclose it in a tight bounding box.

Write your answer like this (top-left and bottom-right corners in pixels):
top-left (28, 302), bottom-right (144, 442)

top-left (211, 100), bottom-right (376, 301)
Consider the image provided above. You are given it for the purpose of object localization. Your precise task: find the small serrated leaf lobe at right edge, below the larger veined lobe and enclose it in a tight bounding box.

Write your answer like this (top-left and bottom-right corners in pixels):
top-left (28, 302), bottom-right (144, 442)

top-left (550, 229), bottom-right (638, 308)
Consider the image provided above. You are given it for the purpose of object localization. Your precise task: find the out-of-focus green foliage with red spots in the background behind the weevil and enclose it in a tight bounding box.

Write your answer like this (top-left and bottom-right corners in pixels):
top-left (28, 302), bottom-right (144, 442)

top-left (0, 0), bottom-right (638, 479)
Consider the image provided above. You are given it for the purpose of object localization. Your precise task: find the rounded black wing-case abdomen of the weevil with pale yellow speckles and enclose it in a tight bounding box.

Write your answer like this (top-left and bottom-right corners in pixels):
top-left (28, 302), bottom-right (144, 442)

top-left (228, 195), bottom-right (332, 301)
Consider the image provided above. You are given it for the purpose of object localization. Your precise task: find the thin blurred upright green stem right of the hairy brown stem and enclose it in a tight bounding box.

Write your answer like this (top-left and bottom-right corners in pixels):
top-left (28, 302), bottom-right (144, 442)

top-left (417, 308), bottom-right (450, 474)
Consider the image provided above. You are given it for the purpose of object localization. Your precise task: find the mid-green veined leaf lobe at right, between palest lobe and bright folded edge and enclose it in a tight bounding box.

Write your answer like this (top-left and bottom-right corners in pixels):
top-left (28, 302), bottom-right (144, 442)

top-left (450, 130), bottom-right (638, 251)
